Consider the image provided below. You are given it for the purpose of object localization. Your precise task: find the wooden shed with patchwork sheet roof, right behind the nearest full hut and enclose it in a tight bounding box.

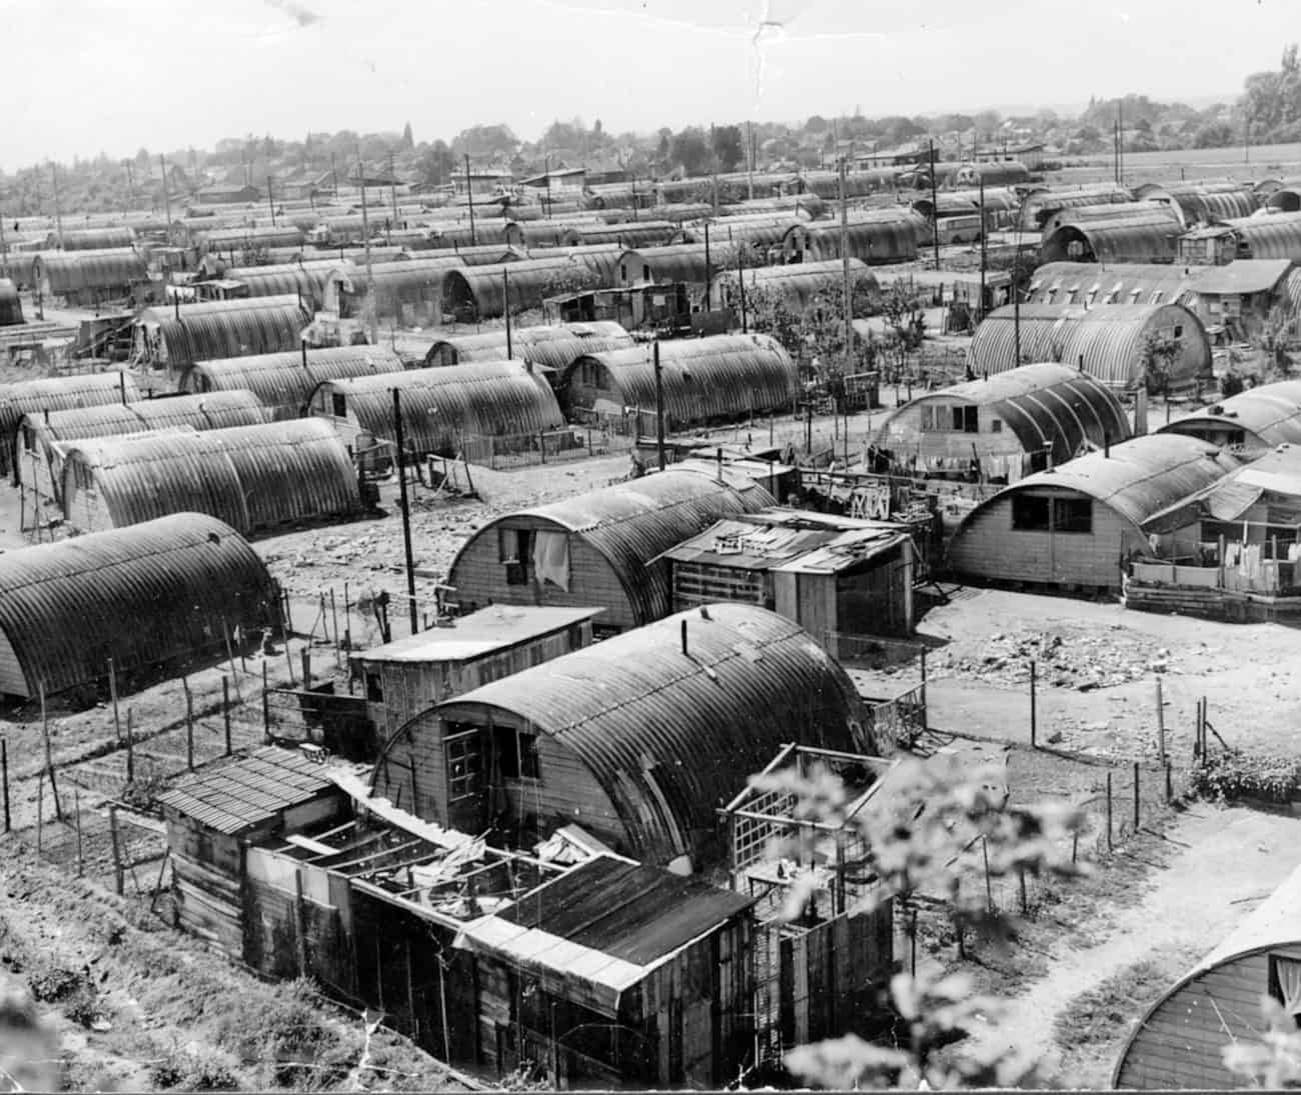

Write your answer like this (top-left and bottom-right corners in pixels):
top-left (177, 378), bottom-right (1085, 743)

top-left (661, 510), bottom-right (915, 634)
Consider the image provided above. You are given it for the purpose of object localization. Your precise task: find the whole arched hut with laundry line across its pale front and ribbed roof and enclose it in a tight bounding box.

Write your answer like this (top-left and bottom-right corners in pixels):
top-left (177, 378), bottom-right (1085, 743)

top-left (873, 363), bottom-right (1131, 482)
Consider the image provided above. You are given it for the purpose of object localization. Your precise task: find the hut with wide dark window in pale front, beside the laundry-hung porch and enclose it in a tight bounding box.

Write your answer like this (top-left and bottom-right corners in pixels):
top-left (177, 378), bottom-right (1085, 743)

top-left (948, 434), bottom-right (1241, 592)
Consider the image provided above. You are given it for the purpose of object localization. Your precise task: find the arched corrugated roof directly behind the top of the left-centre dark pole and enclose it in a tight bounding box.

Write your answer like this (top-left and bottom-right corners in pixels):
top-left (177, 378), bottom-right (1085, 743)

top-left (320, 362), bottom-right (565, 455)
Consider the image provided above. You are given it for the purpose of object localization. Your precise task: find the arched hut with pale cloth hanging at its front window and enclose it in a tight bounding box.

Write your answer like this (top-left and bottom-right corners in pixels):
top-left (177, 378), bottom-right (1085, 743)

top-left (448, 468), bottom-right (773, 631)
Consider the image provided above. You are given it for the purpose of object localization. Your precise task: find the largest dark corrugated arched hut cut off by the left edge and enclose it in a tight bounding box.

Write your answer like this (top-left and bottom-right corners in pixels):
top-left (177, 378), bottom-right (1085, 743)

top-left (0, 514), bottom-right (280, 696)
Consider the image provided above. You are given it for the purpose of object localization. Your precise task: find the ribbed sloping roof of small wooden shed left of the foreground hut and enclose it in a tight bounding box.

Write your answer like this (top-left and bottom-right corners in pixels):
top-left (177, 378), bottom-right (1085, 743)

top-left (157, 745), bottom-right (334, 836)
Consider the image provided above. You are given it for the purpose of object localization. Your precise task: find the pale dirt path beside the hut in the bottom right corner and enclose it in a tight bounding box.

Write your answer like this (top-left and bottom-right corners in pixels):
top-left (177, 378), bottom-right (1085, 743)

top-left (972, 805), bottom-right (1301, 1087)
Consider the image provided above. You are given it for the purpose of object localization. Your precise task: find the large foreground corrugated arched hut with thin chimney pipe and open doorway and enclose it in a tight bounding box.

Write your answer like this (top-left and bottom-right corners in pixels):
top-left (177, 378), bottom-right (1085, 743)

top-left (373, 605), bottom-right (874, 873)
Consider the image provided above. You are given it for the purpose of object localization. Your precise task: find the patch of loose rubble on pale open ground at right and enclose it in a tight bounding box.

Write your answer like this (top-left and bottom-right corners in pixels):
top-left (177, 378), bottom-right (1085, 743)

top-left (933, 624), bottom-right (1177, 692)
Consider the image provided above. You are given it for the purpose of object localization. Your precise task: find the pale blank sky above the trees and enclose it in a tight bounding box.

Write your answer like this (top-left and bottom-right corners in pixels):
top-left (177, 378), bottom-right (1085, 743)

top-left (0, 0), bottom-right (1301, 169)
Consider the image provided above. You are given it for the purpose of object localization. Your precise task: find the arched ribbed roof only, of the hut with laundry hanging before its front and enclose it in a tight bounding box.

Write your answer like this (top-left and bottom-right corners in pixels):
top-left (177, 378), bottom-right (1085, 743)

top-left (877, 363), bottom-right (1132, 464)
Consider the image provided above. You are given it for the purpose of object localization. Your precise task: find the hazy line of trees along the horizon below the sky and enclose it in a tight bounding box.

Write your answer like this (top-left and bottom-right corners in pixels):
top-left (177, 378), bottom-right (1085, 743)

top-left (0, 44), bottom-right (1301, 216)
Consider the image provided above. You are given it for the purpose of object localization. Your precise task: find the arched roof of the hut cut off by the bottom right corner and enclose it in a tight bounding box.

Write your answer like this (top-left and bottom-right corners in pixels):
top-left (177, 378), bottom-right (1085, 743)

top-left (1111, 867), bottom-right (1301, 1090)
